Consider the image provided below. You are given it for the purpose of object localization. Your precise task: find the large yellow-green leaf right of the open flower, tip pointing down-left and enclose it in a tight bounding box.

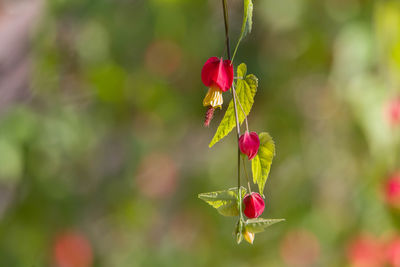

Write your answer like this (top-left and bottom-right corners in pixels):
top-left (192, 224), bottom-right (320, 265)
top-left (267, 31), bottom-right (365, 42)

top-left (209, 63), bottom-right (258, 147)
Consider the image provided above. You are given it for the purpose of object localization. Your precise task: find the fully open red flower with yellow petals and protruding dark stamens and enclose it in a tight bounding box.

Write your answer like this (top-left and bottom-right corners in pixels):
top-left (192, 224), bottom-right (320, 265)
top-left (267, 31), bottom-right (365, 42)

top-left (201, 57), bottom-right (233, 126)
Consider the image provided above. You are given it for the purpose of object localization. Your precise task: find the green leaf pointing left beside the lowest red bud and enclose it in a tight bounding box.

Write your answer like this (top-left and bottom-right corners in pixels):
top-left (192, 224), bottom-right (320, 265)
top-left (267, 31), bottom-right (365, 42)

top-left (199, 187), bottom-right (246, 216)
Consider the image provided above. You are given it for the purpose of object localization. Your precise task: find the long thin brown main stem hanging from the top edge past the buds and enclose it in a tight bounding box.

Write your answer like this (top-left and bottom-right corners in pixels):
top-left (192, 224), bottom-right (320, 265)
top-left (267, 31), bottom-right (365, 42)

top-left (221, 0), bottom-right (243, 220)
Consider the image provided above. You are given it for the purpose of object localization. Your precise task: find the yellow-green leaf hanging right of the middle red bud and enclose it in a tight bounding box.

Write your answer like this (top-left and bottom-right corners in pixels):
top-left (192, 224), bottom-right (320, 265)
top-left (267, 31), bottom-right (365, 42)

top-left (251, 133), bottom-right (275, 194)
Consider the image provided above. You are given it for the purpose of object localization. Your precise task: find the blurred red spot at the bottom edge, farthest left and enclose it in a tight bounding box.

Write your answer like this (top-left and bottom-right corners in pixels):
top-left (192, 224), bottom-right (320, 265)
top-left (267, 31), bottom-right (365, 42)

top-left (53, 231), bottom-right (93, 267)
